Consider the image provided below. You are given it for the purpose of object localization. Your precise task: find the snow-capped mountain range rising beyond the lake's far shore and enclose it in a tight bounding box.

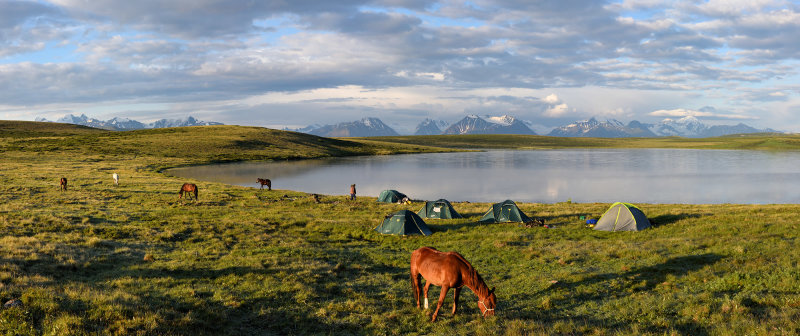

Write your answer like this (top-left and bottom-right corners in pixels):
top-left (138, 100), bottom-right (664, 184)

top-left (284, 115), bottom-right (777, 138)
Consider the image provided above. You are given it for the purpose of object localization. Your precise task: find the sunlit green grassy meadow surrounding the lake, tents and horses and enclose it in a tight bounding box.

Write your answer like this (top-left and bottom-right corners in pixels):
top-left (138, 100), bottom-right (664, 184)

top-left (0, 122), bottom-right (800, 335)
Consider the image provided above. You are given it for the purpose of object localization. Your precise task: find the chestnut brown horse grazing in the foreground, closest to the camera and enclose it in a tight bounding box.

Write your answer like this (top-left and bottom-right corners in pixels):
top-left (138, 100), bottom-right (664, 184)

top-left (411, 247), bottom-right (497, 321)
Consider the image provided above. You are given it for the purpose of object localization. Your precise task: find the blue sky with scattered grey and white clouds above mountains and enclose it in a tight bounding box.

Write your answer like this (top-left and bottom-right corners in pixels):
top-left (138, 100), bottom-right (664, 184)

top-left (0, 0), bottom-right (800, 133)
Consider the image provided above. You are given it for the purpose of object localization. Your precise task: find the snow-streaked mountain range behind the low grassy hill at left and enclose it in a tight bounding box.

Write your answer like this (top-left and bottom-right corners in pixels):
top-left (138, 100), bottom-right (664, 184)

top-left (36, 114), bottom-right (222, 131)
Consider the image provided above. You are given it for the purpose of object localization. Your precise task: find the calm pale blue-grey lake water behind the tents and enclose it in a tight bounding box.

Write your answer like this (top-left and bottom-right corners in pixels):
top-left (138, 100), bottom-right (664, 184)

top-left (169, 149), bottom-right (800, 204)
